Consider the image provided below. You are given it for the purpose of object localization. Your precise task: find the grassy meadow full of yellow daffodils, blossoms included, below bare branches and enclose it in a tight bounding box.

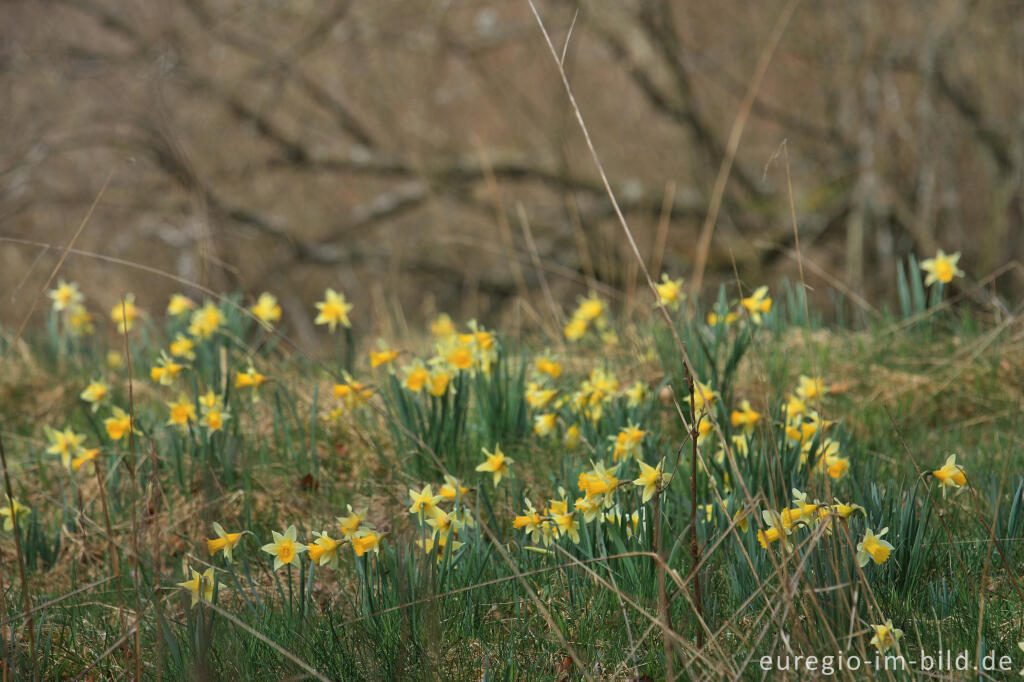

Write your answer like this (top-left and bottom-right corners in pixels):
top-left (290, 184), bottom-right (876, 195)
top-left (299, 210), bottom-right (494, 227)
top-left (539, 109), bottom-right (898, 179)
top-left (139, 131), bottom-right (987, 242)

top-left (0, 242), bottom-right (1024, 680)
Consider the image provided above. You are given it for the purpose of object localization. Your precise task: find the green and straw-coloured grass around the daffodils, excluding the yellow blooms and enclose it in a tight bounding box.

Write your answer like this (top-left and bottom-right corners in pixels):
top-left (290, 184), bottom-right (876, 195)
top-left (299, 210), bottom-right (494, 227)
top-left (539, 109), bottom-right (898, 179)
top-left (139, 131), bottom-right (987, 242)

top-left (0, 274), bottom-right (1024, 680)
